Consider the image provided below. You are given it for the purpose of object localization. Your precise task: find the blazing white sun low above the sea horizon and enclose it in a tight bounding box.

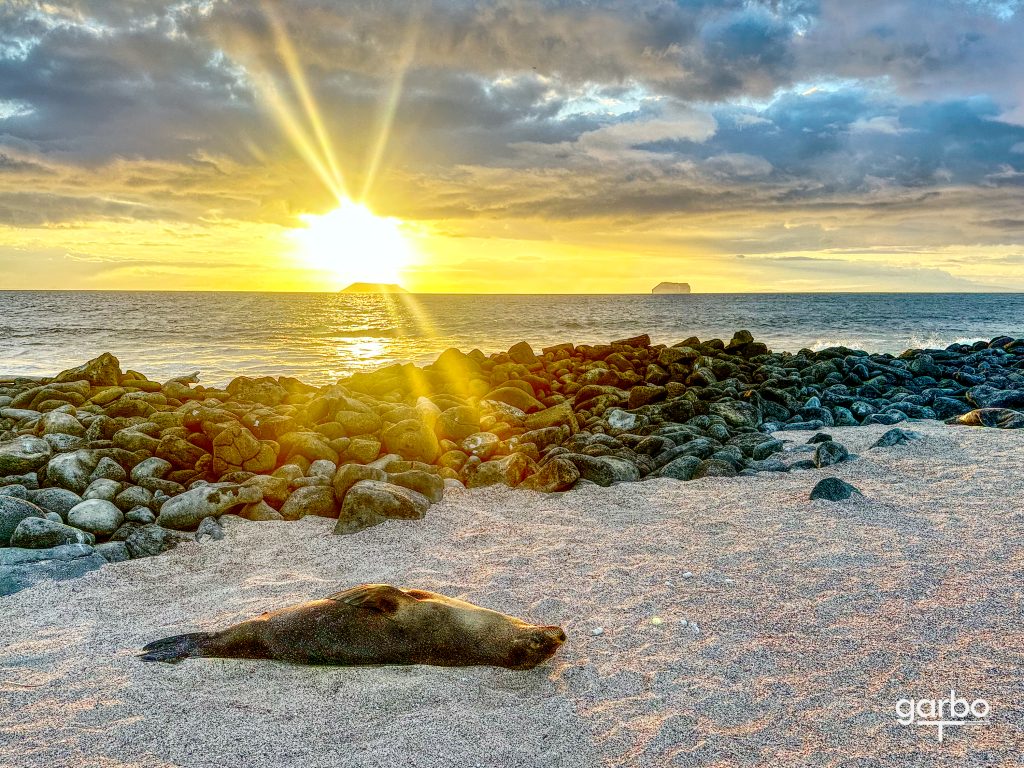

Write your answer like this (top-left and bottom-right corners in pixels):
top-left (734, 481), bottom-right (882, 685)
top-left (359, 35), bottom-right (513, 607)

top-left (291, 200), bottom-right (413, 283)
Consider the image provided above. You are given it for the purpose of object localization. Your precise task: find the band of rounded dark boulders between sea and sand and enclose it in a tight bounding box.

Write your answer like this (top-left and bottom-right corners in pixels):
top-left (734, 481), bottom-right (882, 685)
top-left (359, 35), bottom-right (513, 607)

top-left (0, 331), bottom-right (1024, 594)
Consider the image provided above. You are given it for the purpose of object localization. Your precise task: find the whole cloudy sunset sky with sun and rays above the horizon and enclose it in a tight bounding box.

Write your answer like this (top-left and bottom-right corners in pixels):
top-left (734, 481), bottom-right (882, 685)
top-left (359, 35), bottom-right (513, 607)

top-left (0, 0), bottom-right (1024, 293)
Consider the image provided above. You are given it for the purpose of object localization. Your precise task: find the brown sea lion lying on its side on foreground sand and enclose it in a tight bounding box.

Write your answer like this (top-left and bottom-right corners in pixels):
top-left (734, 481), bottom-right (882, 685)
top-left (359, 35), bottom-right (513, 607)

top-left (140, 584), bottom-right (565, 670)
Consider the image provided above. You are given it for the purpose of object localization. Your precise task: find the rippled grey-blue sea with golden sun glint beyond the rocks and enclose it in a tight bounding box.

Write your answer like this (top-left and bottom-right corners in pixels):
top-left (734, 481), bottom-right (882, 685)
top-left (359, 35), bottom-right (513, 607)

top-left (0, 291), bottom-right (1024, 384)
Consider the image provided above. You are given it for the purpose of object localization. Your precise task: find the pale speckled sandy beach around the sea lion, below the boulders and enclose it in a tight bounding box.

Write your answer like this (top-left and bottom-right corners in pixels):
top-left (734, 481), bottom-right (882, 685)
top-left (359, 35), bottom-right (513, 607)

top-left (0, 422), bottom-right (1024, 768)
